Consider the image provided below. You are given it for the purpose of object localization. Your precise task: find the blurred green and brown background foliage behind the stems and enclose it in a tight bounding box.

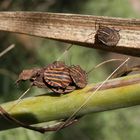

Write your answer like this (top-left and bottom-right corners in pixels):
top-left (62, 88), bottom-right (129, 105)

top-left (0, 0), bottom-right (140, 140)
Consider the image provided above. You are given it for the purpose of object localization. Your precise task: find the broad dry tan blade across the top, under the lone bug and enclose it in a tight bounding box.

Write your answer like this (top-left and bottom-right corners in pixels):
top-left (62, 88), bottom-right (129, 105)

top-left (0, 12), bottom-right (140, 57)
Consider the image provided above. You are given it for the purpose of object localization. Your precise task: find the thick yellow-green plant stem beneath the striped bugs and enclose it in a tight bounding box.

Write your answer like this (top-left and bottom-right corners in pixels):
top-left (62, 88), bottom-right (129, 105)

top-left (0, 74), bottom-right (140, 130)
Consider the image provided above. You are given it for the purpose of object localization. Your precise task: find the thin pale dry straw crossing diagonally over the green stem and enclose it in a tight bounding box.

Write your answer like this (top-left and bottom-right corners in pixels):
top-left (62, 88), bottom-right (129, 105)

top-left (57, 57), bottom-right (130, 131)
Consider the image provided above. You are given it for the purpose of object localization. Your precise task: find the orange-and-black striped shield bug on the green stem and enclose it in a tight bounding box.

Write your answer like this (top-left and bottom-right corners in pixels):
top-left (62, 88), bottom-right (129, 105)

top-left (44, 61), bottom-right (76, 93)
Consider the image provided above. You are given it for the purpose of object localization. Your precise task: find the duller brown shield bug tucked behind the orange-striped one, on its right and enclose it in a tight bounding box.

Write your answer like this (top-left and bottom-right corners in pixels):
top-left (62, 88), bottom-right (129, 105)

top-left (69, 65), bottom-right (87, 88)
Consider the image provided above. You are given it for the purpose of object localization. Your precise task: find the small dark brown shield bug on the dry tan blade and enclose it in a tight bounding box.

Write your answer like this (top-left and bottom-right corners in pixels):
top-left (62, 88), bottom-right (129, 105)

top-left (95, 26), bottom-right (120, 46)
